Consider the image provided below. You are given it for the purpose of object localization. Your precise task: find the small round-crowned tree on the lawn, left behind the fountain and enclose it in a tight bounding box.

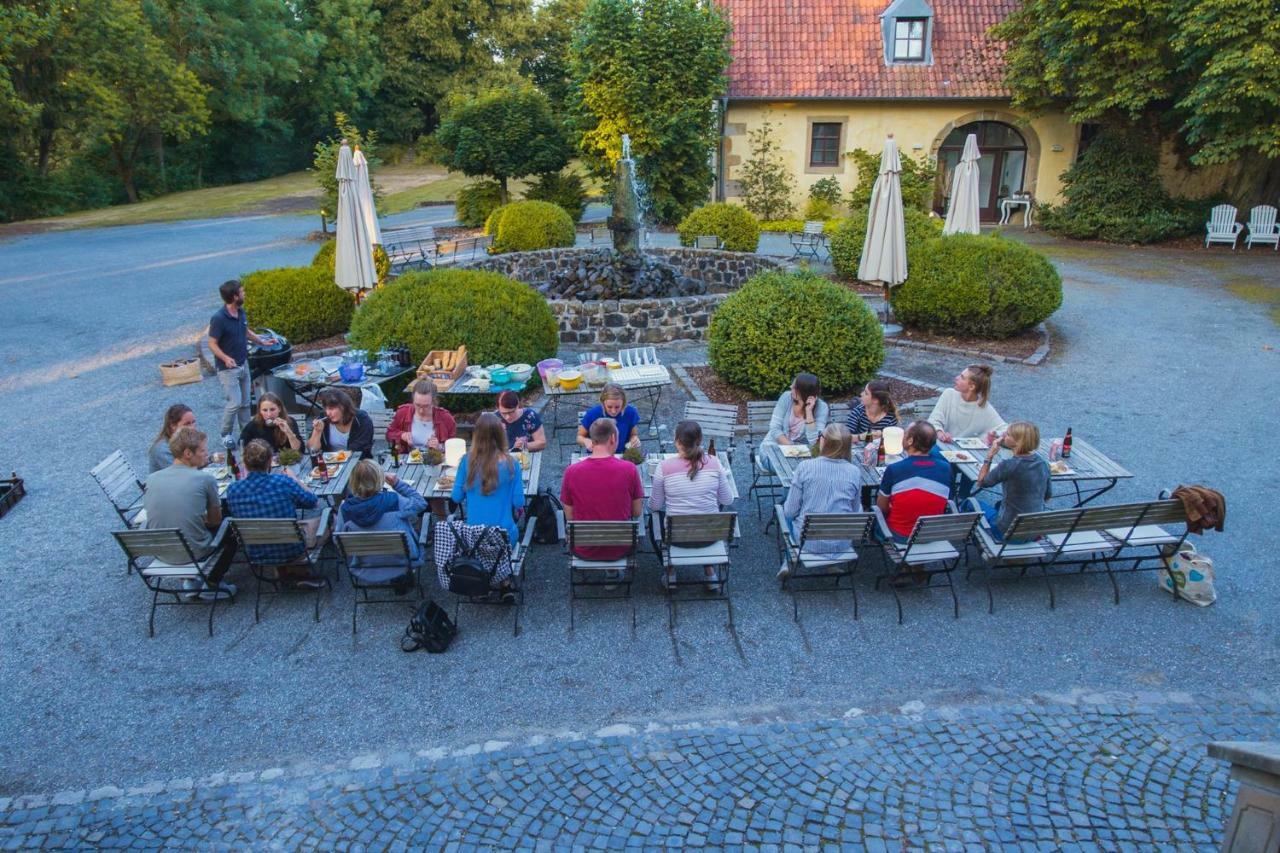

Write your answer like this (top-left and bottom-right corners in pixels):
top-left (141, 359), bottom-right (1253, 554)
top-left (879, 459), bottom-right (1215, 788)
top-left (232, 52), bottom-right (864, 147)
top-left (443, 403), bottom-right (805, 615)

top-left (435, 86), bottom-right (572, 204)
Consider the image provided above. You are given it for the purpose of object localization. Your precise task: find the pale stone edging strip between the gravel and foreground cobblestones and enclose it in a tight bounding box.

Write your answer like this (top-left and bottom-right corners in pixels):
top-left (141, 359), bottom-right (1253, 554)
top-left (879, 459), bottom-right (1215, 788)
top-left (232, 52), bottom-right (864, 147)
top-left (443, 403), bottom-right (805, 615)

top-left (0, 688), bottom-right (1280, 816)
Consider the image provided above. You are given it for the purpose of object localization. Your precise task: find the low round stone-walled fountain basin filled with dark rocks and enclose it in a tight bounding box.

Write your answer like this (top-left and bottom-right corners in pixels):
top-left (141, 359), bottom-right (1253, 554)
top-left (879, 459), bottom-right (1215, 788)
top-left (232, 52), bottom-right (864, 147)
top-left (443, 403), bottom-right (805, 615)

top-left (465, 247), bottom-right (788, 345)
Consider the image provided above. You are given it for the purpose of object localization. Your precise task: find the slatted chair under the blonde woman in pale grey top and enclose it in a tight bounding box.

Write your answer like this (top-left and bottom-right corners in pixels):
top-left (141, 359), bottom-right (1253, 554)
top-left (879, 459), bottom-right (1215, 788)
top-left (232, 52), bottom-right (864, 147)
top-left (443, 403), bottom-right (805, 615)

top-left (774, 503), bottom-right (876, 621)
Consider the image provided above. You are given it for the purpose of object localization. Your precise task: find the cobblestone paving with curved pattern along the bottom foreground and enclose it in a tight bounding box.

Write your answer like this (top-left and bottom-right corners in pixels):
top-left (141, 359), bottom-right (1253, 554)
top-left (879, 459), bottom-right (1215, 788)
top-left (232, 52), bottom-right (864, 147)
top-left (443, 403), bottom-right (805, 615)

top-left (0, 694), bottom-right (1264, 850)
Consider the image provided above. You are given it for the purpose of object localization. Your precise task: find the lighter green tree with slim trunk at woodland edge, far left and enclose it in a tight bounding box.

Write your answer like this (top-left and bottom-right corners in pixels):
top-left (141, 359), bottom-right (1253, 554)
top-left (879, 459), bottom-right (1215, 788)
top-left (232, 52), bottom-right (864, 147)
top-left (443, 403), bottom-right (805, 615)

top-left (67, 0), bottom-right (209, 201)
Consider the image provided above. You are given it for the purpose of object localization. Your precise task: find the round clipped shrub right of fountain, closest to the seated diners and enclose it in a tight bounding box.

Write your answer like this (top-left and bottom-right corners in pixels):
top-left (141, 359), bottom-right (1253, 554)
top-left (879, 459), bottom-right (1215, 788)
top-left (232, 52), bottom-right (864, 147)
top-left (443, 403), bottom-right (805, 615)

top-left (708, 270), bottom-right (884, 397)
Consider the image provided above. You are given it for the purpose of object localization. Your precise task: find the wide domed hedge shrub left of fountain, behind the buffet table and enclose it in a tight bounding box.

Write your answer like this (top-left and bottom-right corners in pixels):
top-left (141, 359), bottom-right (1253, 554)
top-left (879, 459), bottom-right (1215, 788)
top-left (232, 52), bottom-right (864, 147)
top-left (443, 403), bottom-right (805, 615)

top-left (349, 269), bottom-right (559, 365)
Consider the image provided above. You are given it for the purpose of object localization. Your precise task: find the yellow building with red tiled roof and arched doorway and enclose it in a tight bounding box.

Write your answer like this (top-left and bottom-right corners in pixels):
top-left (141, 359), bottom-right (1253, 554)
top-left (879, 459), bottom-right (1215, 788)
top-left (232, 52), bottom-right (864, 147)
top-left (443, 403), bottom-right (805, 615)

top-left (717, 0), bottom-right (1079, 219)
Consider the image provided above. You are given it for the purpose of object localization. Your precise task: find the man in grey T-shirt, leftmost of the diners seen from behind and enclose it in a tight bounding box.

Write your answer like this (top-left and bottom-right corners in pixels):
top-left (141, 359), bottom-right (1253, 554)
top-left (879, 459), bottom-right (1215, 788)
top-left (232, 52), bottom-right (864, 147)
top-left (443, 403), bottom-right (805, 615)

top-left (142, 427), bottom-right (236, 599)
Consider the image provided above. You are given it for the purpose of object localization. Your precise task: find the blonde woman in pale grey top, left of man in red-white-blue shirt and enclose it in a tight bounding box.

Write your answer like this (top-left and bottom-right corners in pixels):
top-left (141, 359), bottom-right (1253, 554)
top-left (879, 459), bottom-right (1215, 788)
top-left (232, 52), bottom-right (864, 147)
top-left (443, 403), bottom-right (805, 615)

top-left (778, 424), bottom-right (863, 580)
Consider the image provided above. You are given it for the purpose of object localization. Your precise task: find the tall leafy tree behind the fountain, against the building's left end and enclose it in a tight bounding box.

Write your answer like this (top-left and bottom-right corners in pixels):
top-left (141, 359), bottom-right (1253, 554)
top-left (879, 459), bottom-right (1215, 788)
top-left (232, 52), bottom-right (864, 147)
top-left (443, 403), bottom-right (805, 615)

top-left (570, 0), bottom-right (730, 224)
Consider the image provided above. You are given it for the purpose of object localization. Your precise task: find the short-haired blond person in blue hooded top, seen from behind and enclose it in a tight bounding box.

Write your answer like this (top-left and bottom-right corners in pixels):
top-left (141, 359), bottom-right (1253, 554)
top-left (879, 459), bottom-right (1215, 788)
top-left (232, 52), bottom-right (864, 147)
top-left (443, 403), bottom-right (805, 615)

top-left (335, 459), bottom-right (426, 592)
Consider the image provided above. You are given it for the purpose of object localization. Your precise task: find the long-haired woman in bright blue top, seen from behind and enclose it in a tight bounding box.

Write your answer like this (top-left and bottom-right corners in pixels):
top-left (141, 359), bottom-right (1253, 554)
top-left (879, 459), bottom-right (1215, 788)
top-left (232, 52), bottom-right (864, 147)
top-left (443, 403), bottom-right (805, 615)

top-left (452, 412), bottom-right (525, 546)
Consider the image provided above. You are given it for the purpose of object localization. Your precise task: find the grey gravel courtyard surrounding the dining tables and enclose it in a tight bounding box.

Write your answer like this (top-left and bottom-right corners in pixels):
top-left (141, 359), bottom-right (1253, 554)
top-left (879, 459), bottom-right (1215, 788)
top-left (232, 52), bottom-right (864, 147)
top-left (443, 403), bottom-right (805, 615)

top-left (0, 211), bottom-right (1280, 797)
